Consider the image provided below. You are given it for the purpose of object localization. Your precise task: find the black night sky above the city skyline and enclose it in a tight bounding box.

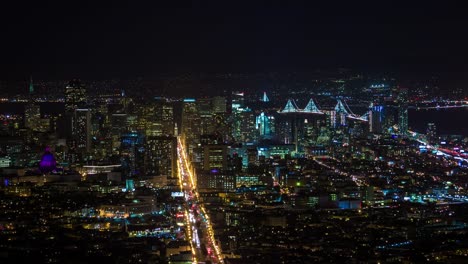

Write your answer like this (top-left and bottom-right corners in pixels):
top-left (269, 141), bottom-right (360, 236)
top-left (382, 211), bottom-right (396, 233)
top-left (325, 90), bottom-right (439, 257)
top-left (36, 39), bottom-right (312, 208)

top-left (0, 1), bottom-right (468, 83)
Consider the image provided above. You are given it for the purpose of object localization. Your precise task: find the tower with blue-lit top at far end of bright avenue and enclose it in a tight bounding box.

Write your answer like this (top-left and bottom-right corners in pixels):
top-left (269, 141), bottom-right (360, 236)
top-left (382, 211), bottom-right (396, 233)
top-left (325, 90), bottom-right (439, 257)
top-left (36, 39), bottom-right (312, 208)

top-left (181, 99), bottom-right (201, 159)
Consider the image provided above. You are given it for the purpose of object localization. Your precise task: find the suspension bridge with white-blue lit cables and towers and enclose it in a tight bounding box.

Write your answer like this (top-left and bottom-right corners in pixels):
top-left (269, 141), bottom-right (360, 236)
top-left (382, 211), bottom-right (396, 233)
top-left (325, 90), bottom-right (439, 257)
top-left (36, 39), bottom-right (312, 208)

top-left (278, 98), bottom-right (369, 122)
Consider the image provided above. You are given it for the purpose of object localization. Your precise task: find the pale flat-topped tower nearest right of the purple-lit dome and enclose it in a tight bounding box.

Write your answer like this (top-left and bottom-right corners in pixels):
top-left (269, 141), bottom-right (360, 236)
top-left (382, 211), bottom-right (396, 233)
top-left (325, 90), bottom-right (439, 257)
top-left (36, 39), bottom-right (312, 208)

top-left (72, 108), bottom-right (91, 152)
